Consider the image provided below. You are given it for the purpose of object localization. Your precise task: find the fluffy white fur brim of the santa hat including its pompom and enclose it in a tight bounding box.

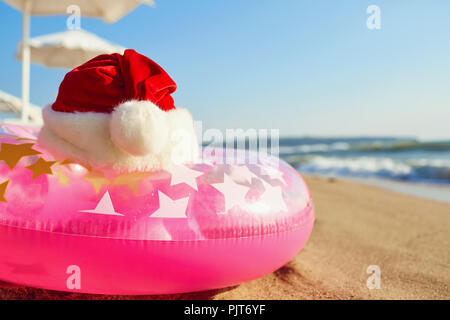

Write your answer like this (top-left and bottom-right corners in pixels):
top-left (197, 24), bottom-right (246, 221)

top-left (38, 101), bottom-right (199, 172)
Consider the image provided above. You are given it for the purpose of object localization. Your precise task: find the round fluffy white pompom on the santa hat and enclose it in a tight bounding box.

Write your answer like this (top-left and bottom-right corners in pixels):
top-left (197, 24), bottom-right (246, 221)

top-left (110, 100), bottom-right (169, 156)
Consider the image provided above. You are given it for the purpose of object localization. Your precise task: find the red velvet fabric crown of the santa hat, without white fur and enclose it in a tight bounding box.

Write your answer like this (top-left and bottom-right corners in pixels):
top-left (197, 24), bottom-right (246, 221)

top-left (52, 49), bottom-right (177, 113)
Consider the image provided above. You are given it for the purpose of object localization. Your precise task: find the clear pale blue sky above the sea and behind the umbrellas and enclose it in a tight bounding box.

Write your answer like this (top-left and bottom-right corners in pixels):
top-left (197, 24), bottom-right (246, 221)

top-left (0, 0), bottom-right (450, 140)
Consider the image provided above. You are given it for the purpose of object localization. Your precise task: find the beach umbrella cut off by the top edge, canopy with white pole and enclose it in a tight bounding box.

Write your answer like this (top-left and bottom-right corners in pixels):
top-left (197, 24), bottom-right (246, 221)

top-left (4, 0), bottom-right (154, 122)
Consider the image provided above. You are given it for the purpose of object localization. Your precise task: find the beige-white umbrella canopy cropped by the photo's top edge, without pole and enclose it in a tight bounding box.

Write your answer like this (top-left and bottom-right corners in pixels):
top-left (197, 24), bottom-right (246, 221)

top-left (4, 0), bottom-right (154, 23)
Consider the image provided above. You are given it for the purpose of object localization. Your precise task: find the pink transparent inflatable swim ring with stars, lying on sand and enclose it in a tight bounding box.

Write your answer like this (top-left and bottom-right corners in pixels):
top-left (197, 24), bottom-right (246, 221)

top-left (0, 126), bottom-right (314, 294)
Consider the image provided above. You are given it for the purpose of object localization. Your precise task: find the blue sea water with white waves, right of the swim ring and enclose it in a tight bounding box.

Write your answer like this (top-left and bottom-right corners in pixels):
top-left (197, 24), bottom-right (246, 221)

top-left (279, 138), bottom-right (450, 202)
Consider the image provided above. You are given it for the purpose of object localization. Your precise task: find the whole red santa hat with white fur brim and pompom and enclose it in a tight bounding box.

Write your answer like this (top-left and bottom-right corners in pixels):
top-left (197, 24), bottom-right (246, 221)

top-left (39, 50), bottom-right (198, 171)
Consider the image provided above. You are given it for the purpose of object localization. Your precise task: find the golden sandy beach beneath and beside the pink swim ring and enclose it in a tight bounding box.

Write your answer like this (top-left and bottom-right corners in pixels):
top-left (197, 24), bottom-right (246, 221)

top-left (0, 177), bottom-right (450, 299)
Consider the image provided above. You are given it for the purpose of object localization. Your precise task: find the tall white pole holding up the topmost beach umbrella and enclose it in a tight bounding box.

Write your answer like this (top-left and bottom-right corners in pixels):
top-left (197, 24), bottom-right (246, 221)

top-left (21, 0), bottom-right (31, 123)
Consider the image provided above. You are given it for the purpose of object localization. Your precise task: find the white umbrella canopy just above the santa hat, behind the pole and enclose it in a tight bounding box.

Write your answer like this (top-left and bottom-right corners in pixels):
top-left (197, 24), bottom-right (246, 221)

top-left (16, 30), bottom-right (125, 69)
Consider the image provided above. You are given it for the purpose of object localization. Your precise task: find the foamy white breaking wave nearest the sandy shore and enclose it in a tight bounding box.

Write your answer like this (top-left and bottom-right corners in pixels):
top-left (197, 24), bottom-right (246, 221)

top-left (287, 156), bottom-right (450, 183)
